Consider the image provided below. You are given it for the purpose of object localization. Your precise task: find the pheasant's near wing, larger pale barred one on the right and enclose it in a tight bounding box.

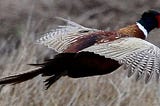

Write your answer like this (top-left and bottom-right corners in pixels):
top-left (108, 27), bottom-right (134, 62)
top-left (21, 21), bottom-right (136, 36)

top-left (82, 37), bottom-right (160, 83)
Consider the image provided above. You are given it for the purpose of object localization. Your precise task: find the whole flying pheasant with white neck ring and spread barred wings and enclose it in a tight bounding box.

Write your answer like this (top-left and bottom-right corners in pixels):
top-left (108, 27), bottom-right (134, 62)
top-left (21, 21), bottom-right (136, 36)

top-left (0, 10), bottom-right (160, 89)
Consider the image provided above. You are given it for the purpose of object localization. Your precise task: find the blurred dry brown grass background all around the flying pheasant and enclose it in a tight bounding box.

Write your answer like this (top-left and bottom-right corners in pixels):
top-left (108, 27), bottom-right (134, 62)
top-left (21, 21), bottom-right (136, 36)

top-left (0, 0), bottom-right (160, 106)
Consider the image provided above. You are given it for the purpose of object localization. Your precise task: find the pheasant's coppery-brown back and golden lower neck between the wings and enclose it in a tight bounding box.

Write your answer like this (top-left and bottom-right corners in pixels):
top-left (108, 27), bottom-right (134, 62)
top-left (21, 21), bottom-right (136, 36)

top-left (64, 24), bottom-right (145, 52)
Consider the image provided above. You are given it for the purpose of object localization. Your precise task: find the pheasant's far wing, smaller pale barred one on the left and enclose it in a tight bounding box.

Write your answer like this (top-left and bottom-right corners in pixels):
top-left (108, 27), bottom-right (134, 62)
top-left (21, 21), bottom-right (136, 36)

top-left (37, 17), bottom-right (98, 53)
